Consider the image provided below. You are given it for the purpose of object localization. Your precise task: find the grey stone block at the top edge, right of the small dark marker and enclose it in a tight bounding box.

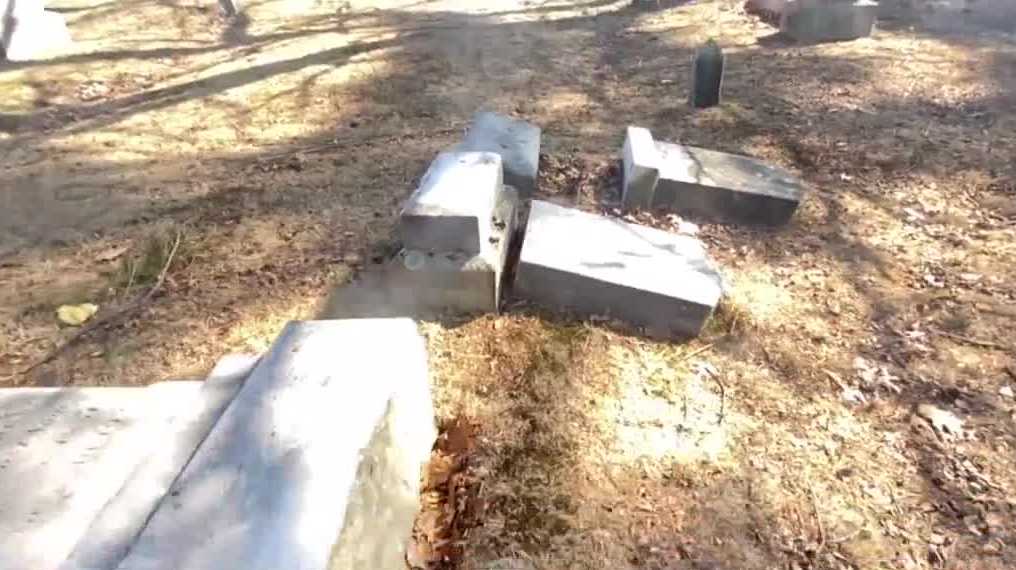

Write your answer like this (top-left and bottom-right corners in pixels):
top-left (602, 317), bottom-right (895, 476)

top-left (779, 0), bottom-right (879, 43)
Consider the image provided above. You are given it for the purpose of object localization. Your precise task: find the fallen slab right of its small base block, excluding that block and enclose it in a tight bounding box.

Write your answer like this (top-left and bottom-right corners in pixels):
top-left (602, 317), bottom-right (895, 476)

top-left (652, 142), bottom-right (803, 226)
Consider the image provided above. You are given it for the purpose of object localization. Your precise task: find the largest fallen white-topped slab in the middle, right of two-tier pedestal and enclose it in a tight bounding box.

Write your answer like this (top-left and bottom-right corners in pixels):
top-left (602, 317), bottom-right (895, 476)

top-left (515, 200), bottom-right (721, 336)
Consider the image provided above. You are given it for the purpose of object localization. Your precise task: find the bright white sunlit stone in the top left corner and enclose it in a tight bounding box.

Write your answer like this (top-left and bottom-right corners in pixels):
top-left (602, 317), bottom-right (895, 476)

top-left (0, 0), bottom-right (71, 61)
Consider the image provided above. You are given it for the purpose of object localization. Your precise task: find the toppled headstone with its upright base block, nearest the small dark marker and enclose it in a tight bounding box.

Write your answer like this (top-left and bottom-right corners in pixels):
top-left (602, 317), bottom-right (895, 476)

top-left (622, 128), bottom-right (803, 226)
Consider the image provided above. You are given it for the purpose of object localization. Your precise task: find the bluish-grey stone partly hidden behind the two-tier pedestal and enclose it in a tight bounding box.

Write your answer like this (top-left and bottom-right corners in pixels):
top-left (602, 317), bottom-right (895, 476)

top-left (457, 111), bottom-right (541, 198)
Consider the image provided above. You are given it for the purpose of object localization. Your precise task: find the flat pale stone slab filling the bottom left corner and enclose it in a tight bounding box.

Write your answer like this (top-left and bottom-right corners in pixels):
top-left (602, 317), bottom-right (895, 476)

top-left (0, 382), bottom-right (201, 570)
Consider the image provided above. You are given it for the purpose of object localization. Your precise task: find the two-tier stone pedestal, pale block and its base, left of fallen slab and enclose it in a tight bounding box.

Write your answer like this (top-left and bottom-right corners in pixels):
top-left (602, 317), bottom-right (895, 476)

top-left (388, 152), bottom-right (519, 317)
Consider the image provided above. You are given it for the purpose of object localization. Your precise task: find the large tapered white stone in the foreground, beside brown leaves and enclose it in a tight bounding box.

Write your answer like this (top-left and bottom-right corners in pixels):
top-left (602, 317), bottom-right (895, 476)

top-left (119, 319), bottom-right (436, 570)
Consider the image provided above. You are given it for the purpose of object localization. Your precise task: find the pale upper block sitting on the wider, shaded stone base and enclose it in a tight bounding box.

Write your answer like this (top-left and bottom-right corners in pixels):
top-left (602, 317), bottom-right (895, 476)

top-left (399, 152), bottom-right (504, 254)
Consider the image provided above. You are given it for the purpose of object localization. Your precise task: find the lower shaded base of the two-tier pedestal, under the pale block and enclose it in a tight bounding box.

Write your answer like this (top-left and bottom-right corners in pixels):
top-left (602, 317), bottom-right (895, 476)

top-left (323, 187), bottom-right (518, 319)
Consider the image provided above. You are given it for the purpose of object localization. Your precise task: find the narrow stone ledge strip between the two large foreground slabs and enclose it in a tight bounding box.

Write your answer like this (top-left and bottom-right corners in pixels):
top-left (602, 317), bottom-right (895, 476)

top-left (60, 355), bottom-right (258, 570)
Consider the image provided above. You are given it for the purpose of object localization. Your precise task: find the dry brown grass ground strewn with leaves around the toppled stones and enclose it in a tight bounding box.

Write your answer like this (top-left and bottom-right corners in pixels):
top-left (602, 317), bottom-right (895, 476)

top-left (0, 0), bottom-right (1016, 569)
